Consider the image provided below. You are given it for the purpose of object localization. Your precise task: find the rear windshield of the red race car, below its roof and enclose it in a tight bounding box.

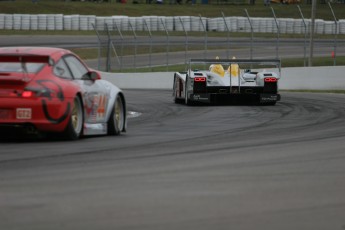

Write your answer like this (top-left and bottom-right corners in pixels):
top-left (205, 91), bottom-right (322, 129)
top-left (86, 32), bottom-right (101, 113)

top-left (0, 62), bottom-right (46, 73)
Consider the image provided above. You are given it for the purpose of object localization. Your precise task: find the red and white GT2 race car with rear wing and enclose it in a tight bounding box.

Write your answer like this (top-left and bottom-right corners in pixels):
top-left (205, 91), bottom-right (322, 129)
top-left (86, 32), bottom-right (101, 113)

top-left (0, 47), bottom-right (127, 140)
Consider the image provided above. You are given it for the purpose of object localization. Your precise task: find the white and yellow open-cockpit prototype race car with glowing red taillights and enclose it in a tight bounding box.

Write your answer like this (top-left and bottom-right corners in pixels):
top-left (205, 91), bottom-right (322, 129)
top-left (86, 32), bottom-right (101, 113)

top-left (173, 58), bottom-right (281, 105)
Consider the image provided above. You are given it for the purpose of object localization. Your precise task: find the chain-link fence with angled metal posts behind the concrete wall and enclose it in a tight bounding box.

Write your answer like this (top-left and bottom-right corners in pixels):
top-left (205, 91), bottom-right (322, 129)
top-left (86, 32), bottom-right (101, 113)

top-left (94, 7), bottom-right (345, 72)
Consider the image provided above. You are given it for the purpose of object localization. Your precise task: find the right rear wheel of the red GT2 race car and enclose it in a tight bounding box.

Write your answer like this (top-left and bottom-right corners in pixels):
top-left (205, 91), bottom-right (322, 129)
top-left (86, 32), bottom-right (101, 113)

top-left (63, 96), bottom-right (84, 140)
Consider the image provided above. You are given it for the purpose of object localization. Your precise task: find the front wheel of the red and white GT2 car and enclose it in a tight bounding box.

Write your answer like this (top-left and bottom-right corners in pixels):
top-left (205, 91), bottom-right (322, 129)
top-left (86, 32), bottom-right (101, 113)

top-left (108, 95), bottom-right (125, 136)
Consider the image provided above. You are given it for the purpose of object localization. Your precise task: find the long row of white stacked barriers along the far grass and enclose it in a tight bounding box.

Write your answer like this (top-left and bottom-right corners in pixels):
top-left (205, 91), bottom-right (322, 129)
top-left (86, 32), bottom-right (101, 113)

top-left (0, 14), bottom-right (345, 34)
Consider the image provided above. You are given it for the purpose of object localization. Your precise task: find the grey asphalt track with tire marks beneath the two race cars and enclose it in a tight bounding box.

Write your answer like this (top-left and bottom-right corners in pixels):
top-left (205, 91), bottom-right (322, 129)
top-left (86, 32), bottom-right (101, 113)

top-left (0, 90), bottom-right (345, 230)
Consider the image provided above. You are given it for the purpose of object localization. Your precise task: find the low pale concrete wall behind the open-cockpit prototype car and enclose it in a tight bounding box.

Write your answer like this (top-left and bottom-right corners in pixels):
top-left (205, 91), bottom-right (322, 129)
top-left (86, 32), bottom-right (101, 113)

top-left (102, 66), bottom-right (345, 90)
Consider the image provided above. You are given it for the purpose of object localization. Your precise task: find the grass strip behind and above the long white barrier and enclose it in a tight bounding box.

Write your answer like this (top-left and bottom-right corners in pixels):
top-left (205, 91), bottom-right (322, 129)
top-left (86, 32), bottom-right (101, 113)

top-left (0, 0), bottom-right (345, 20)
